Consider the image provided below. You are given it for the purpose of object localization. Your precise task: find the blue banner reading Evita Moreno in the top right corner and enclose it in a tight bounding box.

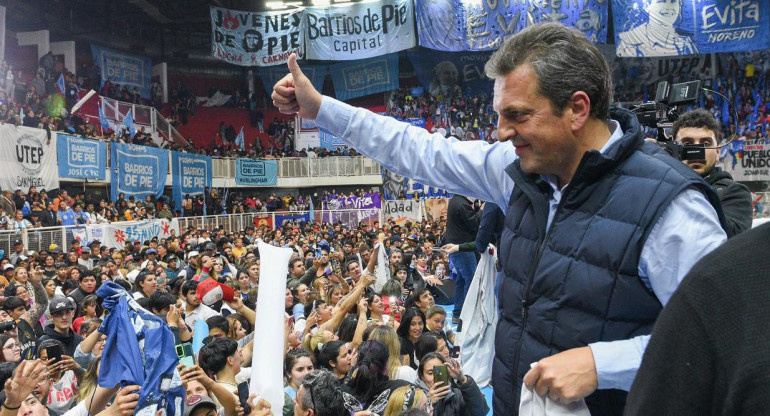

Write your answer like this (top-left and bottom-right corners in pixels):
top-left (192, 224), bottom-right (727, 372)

top-left (612, 0), bottom-right (770, 57)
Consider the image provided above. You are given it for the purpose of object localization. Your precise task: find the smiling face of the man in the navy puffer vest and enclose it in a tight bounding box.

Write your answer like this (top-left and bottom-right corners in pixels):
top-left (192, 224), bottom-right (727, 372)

top-left (493, 65), bottom-right (586, 185)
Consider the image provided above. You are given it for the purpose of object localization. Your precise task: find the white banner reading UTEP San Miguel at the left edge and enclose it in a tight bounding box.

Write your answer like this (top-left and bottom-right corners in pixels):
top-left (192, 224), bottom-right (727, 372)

top-left (0, 124), bottom-right (59, 192)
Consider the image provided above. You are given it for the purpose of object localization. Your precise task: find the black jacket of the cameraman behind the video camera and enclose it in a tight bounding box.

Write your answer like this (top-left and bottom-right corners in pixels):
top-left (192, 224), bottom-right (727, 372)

top-left (703, 167), bottom-right (754, 238)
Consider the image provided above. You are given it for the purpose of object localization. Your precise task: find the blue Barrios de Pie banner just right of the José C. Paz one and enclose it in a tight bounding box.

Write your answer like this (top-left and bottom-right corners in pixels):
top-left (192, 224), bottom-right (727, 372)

top-left (110, 142), bottom-right (168, 201)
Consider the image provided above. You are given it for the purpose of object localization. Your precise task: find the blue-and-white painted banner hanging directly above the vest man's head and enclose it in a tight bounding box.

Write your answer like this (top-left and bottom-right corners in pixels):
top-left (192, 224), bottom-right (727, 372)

top-left (416, 0), bottom-right (617, 52)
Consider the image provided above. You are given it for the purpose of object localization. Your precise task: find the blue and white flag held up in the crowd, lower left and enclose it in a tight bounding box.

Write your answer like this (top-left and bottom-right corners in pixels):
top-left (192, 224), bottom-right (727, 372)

top-left (96, 282), bottom-right (185, 415)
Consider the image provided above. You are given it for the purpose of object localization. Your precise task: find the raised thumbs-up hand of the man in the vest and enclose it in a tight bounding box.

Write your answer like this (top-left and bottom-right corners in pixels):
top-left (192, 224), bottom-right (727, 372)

top-left (271, 53), bottom-right (321, 119)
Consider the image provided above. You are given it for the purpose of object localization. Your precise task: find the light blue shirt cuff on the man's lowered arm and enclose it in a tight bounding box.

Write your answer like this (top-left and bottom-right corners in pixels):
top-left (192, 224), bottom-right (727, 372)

top-left (588, 335), bottom-right (650, 391)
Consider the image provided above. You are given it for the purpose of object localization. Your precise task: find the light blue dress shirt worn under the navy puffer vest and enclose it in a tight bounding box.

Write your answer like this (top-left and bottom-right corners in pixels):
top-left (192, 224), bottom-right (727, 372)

top-left (316, 97), bottom-right (727, 390)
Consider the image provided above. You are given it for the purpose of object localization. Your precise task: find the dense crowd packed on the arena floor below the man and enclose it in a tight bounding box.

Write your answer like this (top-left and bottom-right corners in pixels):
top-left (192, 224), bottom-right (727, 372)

top-left (0, 203), bottom-right (489, 416)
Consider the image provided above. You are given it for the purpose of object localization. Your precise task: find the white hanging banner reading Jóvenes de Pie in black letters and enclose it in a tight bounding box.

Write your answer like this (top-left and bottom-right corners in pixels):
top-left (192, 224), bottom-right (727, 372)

top-left (211, 7), bottom-right (303, 66)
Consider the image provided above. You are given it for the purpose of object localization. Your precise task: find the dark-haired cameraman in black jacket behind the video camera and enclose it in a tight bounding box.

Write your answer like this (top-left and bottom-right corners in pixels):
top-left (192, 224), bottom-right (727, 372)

top-left (671, 109), bottom-right (753, 238)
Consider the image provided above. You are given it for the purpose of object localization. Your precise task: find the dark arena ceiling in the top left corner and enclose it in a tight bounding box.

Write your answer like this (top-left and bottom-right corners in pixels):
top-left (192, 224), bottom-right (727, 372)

top-left (0, 0), bottom-right (292, 58)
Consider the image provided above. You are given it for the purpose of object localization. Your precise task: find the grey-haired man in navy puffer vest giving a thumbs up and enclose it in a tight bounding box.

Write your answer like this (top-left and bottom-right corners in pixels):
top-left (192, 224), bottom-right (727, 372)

top-left (272, 24), bottom-right (726, 416)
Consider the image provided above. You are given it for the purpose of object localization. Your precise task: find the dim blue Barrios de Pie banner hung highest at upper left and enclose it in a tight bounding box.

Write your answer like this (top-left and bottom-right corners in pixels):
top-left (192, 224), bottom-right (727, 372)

top-left (91, 43), bottom-right (152, 99)
